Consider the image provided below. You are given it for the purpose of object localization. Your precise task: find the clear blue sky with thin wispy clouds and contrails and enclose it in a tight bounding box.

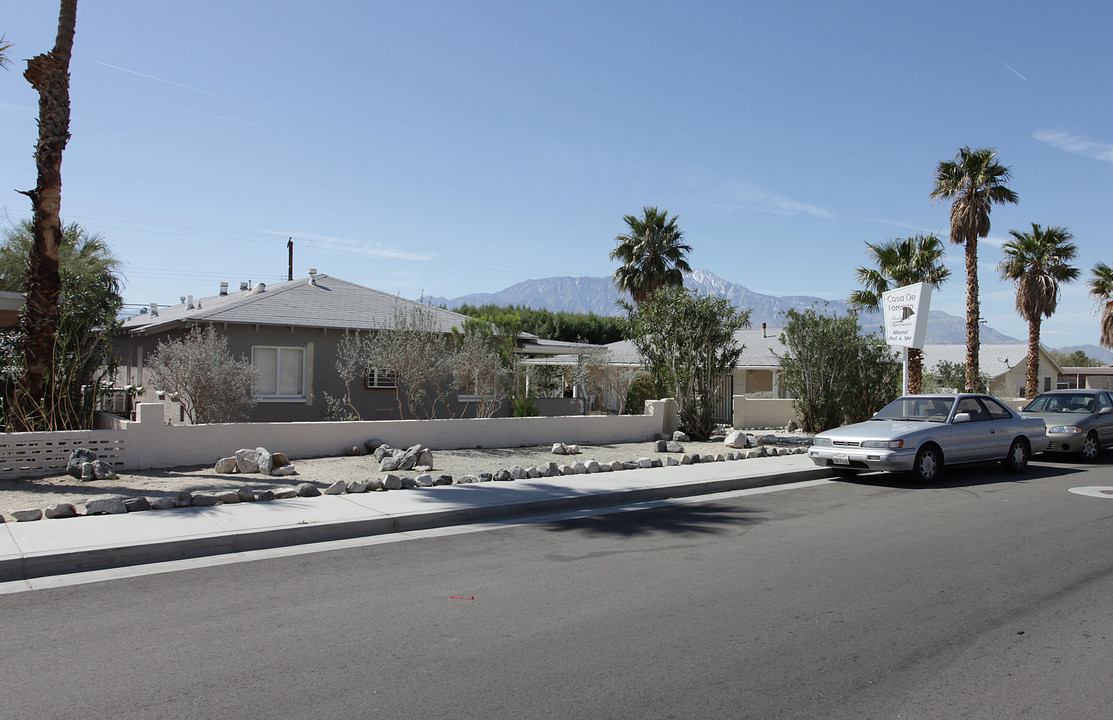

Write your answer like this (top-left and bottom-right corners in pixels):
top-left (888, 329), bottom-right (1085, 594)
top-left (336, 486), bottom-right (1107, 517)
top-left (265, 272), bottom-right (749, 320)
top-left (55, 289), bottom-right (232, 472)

top-left (0, 0), bottom-right (1113, 347)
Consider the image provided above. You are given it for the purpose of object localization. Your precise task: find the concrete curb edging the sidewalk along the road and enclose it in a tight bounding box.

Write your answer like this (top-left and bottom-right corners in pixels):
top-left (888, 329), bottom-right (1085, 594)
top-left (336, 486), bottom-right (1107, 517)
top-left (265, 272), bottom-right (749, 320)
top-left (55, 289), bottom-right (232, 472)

top-left (0, 467), bottom-right (830, 582)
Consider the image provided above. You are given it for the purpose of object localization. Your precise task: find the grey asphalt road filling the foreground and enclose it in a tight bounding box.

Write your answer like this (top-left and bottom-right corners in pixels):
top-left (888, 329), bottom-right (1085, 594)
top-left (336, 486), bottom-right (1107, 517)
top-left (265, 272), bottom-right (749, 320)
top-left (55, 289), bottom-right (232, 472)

top-left (0, 455), bottom-right (1113, 720)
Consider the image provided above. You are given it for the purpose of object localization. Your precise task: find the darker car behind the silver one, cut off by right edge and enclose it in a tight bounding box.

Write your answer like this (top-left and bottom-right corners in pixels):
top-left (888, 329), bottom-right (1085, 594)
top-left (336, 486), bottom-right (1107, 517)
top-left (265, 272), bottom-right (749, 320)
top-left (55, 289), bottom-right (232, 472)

top-left (1021, 389), bottom-right (1113, 460)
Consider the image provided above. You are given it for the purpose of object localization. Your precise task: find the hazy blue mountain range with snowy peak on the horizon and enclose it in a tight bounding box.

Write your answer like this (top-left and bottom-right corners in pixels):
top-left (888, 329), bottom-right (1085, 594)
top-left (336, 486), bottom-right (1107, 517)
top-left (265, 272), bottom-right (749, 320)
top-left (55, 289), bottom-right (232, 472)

top-left (425, 269), bottom-right (1023, 349)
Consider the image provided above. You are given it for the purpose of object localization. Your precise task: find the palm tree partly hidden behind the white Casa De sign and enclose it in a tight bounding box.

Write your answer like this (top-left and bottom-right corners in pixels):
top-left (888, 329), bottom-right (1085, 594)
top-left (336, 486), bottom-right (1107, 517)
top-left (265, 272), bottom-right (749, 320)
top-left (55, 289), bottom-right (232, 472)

top-left (847, 235), bottom-right (951, 395)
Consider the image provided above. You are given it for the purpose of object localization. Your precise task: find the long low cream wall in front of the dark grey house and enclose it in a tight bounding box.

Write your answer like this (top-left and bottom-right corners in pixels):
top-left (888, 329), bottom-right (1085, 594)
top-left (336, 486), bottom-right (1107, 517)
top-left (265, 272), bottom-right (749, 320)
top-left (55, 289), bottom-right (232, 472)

top-left (0, 400), bottom-right (677, 477)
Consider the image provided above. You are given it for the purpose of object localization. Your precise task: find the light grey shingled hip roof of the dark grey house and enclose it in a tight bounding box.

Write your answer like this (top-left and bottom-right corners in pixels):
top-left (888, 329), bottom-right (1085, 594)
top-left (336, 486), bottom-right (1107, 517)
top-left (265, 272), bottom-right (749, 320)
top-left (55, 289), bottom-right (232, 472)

top-left (121, 275), bottom-right (466, 335)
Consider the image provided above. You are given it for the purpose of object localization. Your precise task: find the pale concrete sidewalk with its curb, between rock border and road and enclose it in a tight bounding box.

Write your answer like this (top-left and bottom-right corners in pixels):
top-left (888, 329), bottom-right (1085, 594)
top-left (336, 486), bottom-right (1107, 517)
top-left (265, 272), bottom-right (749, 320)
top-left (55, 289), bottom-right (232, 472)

top-left (0, 455), bottom-right (830, 582)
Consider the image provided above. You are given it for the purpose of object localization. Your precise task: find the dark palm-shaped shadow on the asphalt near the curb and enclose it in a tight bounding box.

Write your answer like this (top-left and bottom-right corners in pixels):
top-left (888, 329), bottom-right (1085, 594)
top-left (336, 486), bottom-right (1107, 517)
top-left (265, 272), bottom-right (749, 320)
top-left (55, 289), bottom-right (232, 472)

top-left (545, 503), bottom-right (764, 537)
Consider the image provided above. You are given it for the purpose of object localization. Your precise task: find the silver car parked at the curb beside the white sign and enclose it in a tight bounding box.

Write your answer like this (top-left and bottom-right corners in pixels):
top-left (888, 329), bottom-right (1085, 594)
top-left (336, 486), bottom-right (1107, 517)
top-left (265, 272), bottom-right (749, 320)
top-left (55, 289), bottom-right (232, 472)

top-left (808, 393), bottom-right (1047, 482)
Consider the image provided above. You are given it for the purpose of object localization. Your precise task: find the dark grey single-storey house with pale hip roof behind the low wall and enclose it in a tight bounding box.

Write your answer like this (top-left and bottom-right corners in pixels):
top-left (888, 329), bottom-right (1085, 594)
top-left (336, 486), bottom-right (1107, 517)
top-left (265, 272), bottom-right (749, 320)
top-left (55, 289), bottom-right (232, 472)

top-left (116, 274), bottom-right (568, 423)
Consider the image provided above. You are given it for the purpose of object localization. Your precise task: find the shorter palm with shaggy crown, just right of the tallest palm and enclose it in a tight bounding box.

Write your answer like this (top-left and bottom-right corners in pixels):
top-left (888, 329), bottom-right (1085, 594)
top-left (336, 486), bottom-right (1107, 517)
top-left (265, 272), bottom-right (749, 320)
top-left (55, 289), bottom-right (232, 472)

top-left (997, 223), bottom-right (1080, 398)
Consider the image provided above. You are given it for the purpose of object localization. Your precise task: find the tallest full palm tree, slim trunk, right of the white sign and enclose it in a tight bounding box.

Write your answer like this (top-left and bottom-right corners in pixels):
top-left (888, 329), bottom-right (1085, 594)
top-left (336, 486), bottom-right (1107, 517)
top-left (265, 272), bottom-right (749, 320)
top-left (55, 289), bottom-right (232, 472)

top-left (932, 147), bottom-right (1020, 389)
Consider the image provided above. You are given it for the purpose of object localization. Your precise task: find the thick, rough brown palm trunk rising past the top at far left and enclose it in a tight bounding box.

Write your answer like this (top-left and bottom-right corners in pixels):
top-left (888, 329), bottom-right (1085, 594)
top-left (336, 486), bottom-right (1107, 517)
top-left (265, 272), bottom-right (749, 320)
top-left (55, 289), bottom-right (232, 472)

top-left (11, 0), bottom-right (77, 430)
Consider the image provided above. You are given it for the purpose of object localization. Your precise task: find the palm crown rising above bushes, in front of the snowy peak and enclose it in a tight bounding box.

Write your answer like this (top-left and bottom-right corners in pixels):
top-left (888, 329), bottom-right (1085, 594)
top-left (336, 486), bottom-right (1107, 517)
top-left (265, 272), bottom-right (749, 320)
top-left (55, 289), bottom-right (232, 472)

top-left (611, 206), bottom-right (692, 305)
